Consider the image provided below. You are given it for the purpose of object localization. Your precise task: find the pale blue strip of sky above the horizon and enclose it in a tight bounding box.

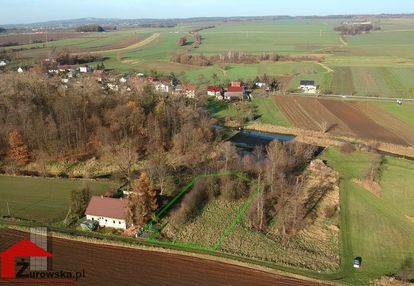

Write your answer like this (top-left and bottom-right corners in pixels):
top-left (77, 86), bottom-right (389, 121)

top-left (0, 0), bottom-right (414, 24)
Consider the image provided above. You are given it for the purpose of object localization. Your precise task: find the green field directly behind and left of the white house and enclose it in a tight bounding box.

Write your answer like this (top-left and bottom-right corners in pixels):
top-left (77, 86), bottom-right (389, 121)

top-left (0, 176), bottom-right (118, 223)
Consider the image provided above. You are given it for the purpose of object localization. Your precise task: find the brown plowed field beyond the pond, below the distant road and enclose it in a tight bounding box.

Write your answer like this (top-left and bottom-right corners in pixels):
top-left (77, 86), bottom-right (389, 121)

top-left (275, 96), bottom-right (414, 145)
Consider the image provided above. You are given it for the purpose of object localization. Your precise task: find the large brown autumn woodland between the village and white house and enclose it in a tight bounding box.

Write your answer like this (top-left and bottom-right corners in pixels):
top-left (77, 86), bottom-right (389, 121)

top-left (0, 73), bottom-right (214, 177)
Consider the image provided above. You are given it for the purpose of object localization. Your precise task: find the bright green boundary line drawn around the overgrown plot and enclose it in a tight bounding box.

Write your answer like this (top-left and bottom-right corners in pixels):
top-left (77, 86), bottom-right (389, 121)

top-left (144, 172), bottom-right (262, 251)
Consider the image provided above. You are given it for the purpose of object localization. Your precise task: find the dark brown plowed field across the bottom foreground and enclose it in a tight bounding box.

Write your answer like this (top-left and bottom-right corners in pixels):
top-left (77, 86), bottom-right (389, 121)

top-left (0, 229), bottom-right (322, 286)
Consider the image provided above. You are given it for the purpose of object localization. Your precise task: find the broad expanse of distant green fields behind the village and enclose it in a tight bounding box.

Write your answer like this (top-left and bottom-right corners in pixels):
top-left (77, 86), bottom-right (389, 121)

top-left (8, 18), bottom-right (414, 98)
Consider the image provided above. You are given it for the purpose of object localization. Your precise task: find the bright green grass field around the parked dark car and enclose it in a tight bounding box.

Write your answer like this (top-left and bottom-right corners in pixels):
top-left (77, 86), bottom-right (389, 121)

top-left (322, 148), bottom-right (414, 285)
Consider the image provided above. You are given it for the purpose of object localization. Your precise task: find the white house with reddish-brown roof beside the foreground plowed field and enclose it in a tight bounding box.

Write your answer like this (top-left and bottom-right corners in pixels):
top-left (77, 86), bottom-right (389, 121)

top-left (85, 197), bottom-right (127, 229)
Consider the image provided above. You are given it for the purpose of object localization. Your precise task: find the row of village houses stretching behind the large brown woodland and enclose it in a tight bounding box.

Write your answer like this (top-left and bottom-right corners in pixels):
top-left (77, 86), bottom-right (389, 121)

top-left (0, 59), bottom-right (317, 98)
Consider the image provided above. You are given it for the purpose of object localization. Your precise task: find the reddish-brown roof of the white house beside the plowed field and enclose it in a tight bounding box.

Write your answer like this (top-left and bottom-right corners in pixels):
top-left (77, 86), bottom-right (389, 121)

top-left (85, 197), bottom-right (127, 219)
